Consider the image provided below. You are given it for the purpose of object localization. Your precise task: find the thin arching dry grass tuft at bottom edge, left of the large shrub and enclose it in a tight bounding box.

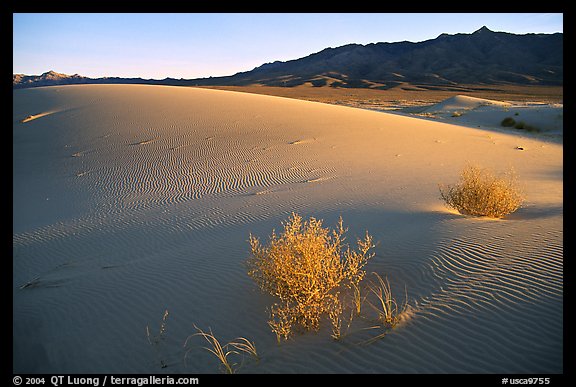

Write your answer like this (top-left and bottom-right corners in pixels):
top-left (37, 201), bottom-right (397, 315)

top-left (184, 325), bottom-right (260, 374)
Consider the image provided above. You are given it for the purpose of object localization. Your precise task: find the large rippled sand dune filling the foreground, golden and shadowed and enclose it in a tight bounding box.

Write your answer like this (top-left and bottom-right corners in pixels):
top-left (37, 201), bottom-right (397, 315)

top-left (13, 85), bottom-right (563, 374)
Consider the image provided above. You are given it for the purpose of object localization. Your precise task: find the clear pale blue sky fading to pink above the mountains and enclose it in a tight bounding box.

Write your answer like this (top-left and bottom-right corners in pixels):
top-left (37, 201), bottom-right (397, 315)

top-left (13, 13), bottom-right (563, 79)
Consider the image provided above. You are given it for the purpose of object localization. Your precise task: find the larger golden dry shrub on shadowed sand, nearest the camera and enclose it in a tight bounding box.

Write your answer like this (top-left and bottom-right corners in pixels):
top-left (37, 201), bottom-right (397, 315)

top-left (247, 213), bottom-right (374, 341)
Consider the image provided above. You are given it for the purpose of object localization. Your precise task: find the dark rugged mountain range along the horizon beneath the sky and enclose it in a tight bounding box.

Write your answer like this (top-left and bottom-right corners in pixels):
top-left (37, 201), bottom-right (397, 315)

top-left (13, 27), bottom-right (563, 89)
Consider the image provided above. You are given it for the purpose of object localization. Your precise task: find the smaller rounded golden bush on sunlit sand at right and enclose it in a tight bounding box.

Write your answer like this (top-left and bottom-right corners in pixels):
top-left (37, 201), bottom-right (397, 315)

top-left (439, 165), bottom-right (523, 218)
